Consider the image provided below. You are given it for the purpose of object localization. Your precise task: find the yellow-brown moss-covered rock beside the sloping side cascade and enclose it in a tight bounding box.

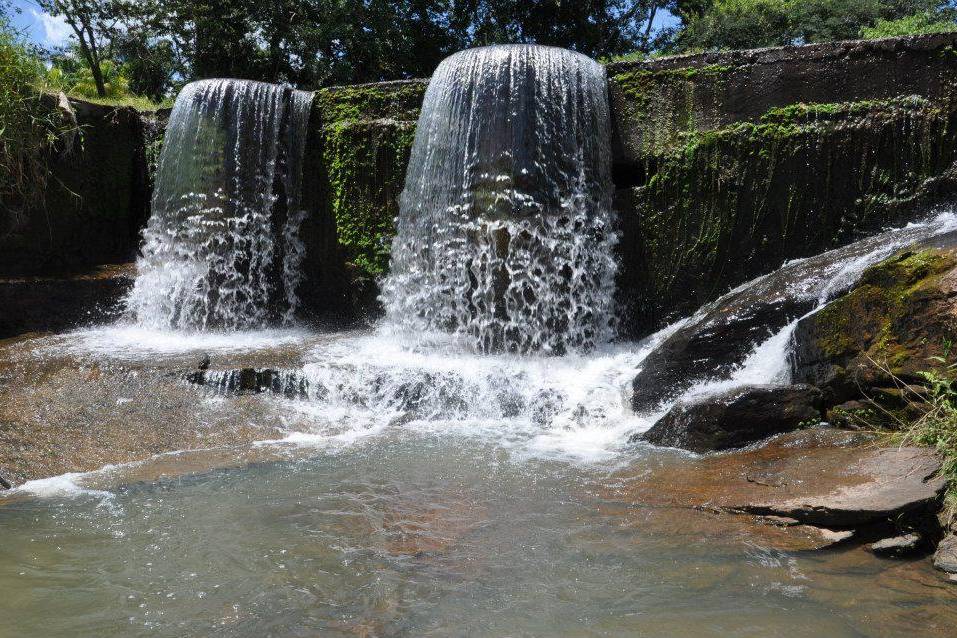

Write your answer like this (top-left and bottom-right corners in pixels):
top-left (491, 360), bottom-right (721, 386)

top-left (792, 249), bottom-right (957, 408)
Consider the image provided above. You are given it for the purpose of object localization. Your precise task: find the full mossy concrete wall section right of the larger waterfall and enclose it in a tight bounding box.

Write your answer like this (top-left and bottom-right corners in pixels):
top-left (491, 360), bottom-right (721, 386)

top-left (608, 34), bottom-right (957, 335)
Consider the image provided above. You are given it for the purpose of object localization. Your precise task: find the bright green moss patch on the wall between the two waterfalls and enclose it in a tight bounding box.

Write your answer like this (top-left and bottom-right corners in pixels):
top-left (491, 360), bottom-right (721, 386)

top-left (323, 121), bottom-right (415, 277)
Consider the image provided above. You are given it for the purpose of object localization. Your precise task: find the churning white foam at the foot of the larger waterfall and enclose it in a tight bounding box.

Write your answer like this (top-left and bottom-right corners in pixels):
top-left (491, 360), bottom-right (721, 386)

top-left (237, 325), bottom-right (677, 462)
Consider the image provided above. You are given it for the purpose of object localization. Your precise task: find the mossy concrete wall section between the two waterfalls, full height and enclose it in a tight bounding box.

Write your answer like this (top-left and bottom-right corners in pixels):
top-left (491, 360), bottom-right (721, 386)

top-left (302, 80), bottom-right (428, 324)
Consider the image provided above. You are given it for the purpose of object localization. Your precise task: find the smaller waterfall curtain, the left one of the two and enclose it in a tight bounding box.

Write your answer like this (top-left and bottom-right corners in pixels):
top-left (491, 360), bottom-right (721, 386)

top-left (127, 80), bottom-right (312, 330)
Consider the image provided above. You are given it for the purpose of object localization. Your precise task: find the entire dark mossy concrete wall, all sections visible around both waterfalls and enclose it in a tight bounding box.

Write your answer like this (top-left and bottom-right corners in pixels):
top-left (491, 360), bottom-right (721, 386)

top-left (7, 34), bottom-right (957, 336)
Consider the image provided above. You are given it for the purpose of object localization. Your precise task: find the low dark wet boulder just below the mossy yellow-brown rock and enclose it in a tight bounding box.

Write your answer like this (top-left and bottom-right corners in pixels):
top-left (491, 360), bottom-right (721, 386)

top-left (641, 385), bottom-right (821, 452)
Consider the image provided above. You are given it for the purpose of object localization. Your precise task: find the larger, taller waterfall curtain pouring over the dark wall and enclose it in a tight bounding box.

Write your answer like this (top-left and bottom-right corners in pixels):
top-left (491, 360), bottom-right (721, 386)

top-left (383, 45), bottom-right (617, 353)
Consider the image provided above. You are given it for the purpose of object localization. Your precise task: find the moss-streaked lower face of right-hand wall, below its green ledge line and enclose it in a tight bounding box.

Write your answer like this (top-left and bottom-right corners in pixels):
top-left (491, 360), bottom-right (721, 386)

top-left (632, 97), bottom-right (957, 330)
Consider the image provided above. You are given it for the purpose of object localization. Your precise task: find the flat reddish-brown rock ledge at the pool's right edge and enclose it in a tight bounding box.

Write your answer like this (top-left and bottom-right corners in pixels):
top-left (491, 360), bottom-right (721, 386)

top-left (608, 429), bottom-right (944, 552)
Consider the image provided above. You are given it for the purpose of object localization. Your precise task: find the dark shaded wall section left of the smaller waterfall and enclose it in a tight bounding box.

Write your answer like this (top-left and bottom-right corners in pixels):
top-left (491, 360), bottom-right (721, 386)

top-left (0, 100), bottom-right (149, 275)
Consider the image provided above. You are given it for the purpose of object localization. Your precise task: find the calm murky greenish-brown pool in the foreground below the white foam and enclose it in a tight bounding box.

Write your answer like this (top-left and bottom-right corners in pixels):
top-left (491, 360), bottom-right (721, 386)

top-left (0, 434), bottom-right (957, 637)
